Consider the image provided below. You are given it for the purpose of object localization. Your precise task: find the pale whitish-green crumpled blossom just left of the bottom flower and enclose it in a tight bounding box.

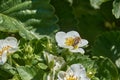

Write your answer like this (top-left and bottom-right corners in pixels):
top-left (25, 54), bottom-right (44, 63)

top-left (43, 51), bottom-right (65, 80)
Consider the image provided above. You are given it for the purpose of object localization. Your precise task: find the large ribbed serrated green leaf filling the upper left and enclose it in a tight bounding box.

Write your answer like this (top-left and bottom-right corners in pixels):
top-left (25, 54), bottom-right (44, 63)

top-left (0, 0), bottom-right (58, 40)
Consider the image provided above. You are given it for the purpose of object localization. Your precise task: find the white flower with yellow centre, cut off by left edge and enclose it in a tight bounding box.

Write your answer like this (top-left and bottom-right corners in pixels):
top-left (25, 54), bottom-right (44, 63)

top-left (0, 37), bottom-right (18, 65)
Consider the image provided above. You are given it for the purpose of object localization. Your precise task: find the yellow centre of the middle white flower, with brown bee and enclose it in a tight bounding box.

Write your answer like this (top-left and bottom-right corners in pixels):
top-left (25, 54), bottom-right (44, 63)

top-left (65, 37), bottom-right (80, 49)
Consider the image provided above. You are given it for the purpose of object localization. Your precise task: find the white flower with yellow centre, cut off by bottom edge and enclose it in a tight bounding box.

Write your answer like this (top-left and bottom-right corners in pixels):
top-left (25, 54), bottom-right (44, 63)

top-left (57, 64), bottom-right (90, 80)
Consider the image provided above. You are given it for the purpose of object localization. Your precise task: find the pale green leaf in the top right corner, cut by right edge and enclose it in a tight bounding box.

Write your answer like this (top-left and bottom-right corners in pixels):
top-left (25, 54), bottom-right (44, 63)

top-left (112, 0), bottom-right (120, 18)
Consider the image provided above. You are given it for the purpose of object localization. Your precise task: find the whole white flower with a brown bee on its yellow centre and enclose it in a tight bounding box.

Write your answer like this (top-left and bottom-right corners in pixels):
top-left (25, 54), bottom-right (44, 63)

top-left (55, 31), bottom-right (88, 54)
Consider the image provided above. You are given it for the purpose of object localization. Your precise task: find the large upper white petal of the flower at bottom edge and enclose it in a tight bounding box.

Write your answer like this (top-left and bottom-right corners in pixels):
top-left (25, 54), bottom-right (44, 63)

top-left (67, 64), bottom-right (86, 77)
